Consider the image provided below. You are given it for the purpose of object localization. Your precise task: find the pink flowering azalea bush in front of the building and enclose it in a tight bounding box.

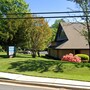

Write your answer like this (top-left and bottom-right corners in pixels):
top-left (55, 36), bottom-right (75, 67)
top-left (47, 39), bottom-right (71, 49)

top-left (62, 53), bottom-right (81, 63)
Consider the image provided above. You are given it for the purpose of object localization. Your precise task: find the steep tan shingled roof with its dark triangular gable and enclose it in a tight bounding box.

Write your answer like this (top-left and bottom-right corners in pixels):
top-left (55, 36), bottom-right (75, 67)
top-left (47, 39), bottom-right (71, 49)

top-left (51, 23), bottom-right (89, 49)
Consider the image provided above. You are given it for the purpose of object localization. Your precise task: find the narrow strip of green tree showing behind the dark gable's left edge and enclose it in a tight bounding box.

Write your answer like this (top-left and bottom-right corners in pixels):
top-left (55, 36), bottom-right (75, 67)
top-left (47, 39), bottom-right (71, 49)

top-left (51, 19), bottom-right (65, 41)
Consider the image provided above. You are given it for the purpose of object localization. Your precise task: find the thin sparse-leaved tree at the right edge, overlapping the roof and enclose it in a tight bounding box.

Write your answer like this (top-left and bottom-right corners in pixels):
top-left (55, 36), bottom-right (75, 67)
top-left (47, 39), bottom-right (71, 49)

top-left (68, 0), bottom-right (90, 62)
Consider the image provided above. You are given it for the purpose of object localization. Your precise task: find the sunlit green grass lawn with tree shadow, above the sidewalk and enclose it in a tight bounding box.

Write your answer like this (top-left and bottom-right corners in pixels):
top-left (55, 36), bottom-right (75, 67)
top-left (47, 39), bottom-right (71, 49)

top-left (0, 52), bottom-right (90, 81)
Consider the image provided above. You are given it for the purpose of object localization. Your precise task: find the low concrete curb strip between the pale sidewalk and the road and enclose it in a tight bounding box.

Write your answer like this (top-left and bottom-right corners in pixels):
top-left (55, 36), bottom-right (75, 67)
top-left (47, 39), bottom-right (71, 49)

top-left (0, 78), bottom-right (90, 90)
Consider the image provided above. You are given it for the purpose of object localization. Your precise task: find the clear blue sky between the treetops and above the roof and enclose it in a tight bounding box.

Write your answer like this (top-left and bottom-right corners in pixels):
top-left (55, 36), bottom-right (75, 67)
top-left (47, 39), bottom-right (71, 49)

top-left (25, 0), bottom-right (77, 26)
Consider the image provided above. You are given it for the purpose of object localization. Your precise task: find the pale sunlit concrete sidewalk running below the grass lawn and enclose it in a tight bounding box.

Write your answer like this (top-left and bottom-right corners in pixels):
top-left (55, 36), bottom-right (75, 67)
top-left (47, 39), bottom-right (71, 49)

top-left (0, 72), bottom-right (90, 90)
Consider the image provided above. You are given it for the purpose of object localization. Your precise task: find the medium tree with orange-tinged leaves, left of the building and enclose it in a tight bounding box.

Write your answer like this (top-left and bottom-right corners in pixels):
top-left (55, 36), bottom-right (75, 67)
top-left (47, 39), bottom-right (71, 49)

top-left (25, 18), bottom-right (52, 57)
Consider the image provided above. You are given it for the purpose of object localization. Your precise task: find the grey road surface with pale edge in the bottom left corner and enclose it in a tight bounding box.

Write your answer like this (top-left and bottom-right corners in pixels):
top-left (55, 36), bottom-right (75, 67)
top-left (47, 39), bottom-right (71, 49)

top-left (0, 82), bottom-right (71, 90)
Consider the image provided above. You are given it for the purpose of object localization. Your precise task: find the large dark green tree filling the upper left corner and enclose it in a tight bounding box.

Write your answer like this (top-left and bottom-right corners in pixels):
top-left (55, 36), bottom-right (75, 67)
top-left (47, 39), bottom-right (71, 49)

top-left (0, 0), bottom-right (29, 49)
